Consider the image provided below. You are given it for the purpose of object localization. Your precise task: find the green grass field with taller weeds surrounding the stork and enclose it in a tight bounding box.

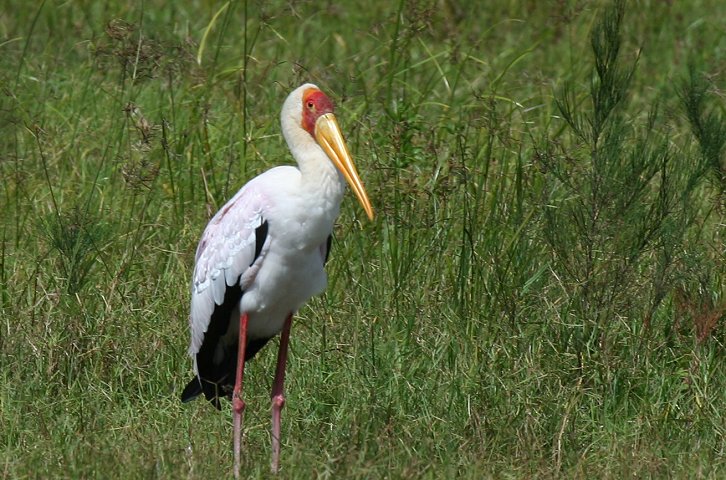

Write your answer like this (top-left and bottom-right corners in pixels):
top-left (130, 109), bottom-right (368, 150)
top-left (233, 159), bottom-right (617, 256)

top-left (0, 0), bottom-right (726, 479)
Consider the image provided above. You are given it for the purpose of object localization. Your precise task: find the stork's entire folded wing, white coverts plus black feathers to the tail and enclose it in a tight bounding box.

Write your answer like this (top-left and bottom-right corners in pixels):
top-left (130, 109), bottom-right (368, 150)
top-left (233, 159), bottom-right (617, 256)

top-left (186, 167), bottom-right (300, 408)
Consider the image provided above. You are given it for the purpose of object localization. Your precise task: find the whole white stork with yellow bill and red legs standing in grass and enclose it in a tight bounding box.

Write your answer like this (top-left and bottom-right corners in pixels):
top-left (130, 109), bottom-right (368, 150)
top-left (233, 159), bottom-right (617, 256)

top-left (181, 83), bottom-right (374, 478)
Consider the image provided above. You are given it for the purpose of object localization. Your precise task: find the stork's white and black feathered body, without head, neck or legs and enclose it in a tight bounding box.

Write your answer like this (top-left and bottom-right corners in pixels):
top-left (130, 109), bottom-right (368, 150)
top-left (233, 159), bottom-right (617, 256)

top-left (184, 165), bottom-right (345, 406)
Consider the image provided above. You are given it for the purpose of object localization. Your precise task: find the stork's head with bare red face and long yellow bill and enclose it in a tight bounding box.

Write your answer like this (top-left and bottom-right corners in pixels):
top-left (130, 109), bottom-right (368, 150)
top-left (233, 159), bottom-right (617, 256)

top-left (282, 83), bottom-right (373, 220)
